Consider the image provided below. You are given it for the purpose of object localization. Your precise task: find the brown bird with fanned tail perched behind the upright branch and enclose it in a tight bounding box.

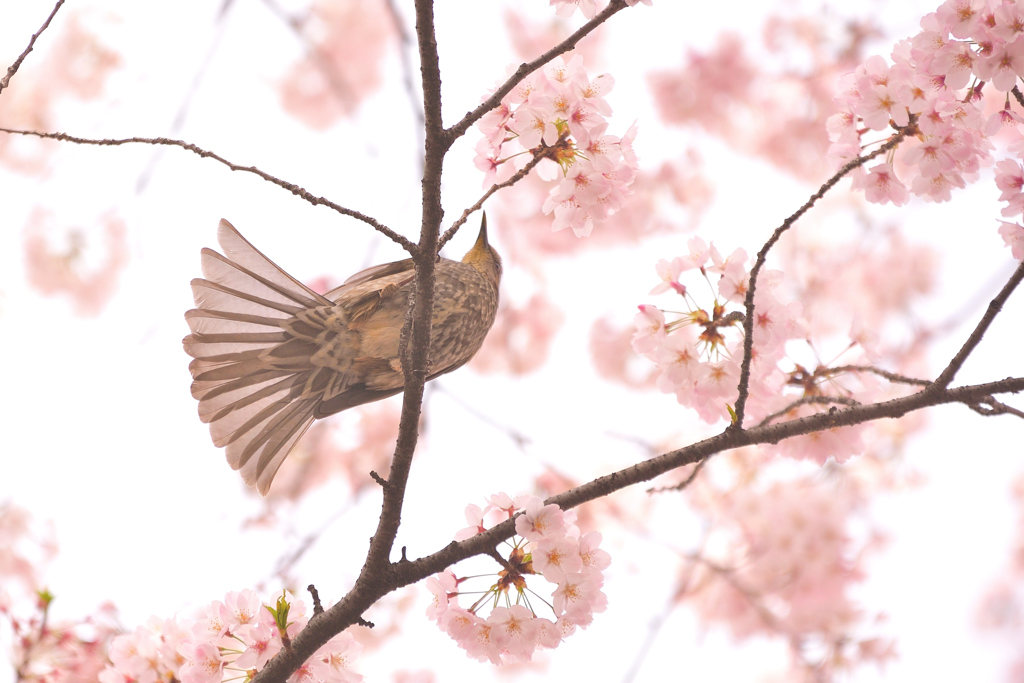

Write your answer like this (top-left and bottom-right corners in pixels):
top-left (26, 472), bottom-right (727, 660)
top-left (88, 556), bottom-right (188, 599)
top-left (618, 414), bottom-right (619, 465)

top-left (182, 218), bottom-right (502, 496)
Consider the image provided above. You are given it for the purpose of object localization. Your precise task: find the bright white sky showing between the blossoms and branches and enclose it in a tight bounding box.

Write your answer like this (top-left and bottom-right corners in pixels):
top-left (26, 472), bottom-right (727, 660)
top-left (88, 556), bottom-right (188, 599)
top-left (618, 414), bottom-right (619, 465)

top-left (0, 0), bottom-right (1024, 681)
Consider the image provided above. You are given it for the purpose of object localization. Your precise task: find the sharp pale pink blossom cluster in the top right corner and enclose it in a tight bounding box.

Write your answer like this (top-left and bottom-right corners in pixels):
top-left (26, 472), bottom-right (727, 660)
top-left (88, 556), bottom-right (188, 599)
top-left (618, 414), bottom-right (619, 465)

top-left (828, 0), bottom-right (1024, 258)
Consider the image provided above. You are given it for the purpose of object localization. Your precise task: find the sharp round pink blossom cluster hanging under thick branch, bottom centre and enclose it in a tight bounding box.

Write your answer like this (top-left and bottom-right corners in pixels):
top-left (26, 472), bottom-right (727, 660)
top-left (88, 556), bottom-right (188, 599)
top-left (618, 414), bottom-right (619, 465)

top-left (427, 494), bottom-right (611, 665)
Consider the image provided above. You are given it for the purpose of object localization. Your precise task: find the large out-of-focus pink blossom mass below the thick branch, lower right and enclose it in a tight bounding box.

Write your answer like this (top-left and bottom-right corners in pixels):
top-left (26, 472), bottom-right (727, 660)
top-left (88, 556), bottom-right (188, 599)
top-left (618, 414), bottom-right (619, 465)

top-left (681, 470), bottom-right (895, 680)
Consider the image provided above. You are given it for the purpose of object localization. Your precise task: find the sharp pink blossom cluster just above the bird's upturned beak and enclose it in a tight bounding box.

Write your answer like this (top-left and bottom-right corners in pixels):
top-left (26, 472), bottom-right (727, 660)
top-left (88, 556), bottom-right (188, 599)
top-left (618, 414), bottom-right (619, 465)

top-left (474, 55), bottom-right (637, 237)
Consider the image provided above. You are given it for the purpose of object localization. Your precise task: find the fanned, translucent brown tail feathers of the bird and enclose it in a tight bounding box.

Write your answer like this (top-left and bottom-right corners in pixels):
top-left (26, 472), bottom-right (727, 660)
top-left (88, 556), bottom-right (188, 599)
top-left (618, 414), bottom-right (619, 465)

top-left (184, 220), bottom-right (332, 495)
